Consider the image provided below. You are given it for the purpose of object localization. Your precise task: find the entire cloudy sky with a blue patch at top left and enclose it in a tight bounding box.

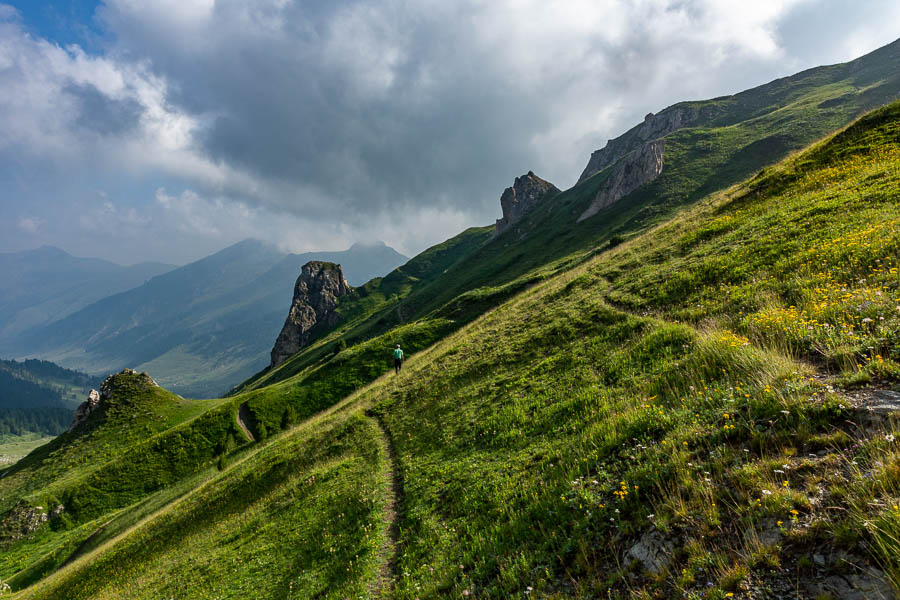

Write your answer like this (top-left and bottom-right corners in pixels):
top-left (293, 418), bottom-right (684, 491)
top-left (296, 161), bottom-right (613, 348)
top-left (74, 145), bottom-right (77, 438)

top-left (0, 0), bottom-right (900, 264)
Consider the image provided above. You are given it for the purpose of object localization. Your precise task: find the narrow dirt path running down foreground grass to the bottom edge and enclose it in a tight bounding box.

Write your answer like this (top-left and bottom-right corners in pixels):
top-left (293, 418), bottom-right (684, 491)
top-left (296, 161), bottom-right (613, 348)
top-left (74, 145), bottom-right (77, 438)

top-left (366, 412), bottom-right (403, 598)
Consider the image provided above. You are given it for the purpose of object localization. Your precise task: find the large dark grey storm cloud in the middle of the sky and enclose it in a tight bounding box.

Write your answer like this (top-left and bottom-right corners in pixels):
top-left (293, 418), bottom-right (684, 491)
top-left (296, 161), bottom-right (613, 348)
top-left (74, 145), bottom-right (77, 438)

top-left (96, 2), bottom-right (554, 216)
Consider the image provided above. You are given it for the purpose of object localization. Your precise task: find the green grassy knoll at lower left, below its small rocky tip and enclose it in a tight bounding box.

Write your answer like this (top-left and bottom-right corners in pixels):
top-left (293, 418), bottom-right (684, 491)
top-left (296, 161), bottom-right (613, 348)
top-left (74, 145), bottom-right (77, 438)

top-left (0, 374), bottom-right (240, 577)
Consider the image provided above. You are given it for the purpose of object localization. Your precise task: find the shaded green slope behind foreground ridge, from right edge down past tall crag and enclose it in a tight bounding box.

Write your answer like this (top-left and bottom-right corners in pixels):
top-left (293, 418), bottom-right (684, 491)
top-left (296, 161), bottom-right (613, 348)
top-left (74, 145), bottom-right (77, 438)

top-left (239, 43), bottom-right (900, 406)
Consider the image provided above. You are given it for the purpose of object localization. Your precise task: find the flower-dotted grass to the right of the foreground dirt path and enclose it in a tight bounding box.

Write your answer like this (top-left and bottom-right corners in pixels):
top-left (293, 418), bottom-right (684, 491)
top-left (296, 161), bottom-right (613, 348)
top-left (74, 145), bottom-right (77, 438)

top-left (340, 105), bottom-right (900, 598)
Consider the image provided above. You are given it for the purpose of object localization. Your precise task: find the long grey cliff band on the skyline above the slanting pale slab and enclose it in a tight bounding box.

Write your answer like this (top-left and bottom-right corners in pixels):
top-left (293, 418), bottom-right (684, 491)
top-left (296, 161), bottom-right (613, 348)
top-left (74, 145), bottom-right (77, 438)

top-left (578, 103), bottom-right (719, 183)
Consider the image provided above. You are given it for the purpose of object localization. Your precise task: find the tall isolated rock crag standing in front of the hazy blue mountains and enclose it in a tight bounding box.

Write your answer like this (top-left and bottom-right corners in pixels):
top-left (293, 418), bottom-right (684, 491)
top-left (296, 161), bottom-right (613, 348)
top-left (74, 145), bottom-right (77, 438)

top-left (272, 261), bottom-right (353, 367)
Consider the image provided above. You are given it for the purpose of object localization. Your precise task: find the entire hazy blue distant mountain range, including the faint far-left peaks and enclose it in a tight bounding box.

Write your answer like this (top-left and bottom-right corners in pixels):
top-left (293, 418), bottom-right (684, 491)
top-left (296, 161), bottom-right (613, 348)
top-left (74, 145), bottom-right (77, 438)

top-left (0, 240), bottom-right (407, 396)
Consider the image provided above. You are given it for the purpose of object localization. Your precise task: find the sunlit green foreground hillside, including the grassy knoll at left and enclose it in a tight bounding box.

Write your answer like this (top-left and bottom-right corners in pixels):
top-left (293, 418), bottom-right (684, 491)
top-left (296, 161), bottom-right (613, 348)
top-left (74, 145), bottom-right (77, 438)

top-left (0, 96), bottom-right (900, 598)
